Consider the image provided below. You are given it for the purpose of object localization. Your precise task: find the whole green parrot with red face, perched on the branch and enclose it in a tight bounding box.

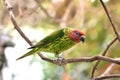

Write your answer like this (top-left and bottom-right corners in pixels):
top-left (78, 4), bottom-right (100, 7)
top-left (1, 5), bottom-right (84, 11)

top-left (17, 28), bottom-right (85, 60)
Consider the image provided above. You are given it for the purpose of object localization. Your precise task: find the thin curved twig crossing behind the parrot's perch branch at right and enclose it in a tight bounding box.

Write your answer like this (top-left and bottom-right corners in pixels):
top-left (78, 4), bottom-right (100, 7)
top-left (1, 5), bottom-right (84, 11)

top-left (91, 37), bottom-right (117, 79)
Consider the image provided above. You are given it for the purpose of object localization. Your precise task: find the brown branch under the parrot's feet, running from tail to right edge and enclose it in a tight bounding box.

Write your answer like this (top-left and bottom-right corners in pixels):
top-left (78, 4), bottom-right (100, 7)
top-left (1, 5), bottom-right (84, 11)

top-left (39, 56), bottom-right (120, 65)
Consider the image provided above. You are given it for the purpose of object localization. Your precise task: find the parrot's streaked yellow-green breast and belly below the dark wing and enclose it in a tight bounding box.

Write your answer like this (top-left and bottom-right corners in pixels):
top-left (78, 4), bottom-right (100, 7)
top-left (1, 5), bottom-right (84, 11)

top-left (41, 36), bottom-right (76, 54)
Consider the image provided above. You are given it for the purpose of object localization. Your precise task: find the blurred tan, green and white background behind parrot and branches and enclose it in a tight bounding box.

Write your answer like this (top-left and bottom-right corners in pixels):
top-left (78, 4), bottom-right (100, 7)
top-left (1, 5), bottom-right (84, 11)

top-left (0, 0), bottom-right (120, 80)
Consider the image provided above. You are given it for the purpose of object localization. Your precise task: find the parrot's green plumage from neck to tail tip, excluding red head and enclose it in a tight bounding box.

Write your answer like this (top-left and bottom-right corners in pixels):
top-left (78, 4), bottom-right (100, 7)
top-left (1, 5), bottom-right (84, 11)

top-left (17, 28), bottom-right (76, 60)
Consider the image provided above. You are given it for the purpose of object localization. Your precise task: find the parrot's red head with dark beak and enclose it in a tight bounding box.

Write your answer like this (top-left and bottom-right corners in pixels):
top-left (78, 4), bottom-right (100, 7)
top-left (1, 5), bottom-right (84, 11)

top-left (68, 30), bottom-right (85, 43)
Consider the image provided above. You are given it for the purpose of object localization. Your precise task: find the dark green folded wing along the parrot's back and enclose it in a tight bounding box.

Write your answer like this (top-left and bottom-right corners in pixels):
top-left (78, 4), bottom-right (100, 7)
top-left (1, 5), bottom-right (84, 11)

top-left (28, 29), bottom-right (64, 49)
